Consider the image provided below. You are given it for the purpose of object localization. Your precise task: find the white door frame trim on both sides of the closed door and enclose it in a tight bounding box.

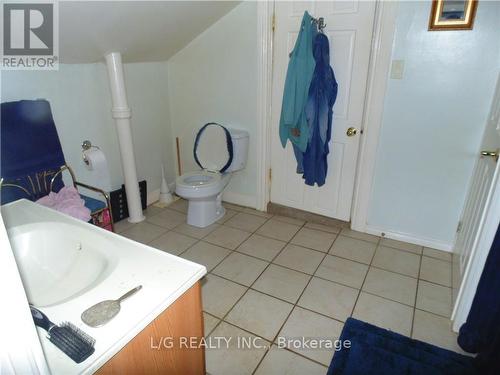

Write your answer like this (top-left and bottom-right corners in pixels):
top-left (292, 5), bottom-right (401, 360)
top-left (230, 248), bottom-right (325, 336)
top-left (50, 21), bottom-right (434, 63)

top-left (256, 1), bottom-right (398, 232)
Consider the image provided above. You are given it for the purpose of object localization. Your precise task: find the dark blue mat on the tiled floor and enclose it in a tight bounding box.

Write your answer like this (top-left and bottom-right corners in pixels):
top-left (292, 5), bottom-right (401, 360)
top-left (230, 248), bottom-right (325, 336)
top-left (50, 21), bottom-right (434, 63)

top-left (328, 318), bottom-right (479, 375)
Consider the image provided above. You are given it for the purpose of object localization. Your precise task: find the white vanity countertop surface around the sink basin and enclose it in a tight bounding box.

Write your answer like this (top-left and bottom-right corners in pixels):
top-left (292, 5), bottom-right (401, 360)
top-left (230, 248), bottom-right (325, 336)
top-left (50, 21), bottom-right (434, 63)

top-left (1, 200), bottom-right (207, 374)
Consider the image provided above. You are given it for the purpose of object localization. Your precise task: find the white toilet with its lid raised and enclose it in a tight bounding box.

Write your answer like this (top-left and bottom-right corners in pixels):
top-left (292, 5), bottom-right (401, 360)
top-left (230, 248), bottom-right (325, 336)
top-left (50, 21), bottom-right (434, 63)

top-left (175, 123), bottom-right (249, 228)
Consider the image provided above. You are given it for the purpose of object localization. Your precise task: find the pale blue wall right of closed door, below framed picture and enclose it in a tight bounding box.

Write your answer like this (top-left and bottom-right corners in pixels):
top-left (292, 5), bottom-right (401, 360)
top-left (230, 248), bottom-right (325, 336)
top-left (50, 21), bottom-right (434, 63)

top-left (368, 1), bottom-right (500, 249)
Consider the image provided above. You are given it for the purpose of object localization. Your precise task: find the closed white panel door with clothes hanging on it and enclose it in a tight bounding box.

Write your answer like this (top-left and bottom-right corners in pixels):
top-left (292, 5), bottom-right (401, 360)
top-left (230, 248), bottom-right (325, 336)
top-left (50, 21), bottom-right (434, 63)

top-left (271, 1), bottom-right (375, 221)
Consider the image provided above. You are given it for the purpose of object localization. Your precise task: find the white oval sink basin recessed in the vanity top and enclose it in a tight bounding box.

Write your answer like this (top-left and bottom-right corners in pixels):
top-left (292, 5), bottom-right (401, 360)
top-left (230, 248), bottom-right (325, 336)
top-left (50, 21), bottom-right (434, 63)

top-left (8, 221), bottom-right (116, 307)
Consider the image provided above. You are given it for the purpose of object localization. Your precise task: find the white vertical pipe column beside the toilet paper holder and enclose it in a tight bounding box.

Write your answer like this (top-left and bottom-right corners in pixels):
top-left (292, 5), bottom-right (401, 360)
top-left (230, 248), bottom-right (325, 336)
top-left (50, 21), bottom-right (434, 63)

top-left (106, 52), bottom-right (145, 223)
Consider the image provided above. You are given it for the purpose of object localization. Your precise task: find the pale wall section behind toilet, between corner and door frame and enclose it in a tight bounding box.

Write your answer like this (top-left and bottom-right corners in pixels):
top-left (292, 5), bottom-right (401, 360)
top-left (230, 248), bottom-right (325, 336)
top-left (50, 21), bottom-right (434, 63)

top-left (167, 2), bottom-right (258, 206)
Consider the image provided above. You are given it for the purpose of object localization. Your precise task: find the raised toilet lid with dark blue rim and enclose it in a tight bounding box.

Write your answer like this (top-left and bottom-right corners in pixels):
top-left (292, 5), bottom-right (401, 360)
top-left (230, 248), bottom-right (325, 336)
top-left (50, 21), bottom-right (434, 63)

top-left (193, 122), bottom-right (233, 173)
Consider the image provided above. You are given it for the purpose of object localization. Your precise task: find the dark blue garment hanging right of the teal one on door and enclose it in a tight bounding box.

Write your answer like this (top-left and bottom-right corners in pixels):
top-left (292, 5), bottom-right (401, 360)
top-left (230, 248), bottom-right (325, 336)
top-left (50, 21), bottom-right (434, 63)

top-left (294, 33), bottom-right (338, 186)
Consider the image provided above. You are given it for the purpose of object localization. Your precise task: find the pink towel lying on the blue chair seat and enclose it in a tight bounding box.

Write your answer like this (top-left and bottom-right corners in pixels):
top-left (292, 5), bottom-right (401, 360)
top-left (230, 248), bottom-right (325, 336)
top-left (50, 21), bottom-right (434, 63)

top-left (36, 186), bottom-right (90, 221)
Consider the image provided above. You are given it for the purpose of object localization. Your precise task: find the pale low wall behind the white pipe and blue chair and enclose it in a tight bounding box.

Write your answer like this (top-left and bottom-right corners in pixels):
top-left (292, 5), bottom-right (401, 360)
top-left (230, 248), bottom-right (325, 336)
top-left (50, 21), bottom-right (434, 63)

top-left (1, 63), bottom-right (175, 200)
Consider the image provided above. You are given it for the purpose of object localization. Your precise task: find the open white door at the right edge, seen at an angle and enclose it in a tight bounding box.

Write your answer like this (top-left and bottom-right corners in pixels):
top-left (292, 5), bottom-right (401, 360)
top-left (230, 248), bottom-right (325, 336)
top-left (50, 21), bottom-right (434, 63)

top-left (453, 76), bottom-right (500, 327)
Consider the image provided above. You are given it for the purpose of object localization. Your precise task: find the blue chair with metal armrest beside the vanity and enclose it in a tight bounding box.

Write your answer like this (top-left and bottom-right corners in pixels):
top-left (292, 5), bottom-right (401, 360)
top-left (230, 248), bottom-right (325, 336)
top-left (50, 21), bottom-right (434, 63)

top-left (0, 99), bottom-right (114, 230)
